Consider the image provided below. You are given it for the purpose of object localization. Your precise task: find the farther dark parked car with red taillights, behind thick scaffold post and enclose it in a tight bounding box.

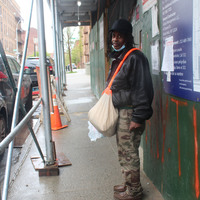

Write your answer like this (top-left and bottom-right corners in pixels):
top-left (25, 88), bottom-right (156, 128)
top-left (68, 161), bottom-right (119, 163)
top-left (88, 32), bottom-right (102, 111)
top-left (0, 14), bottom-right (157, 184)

top-left (24, 57), bottom-right (55, 87)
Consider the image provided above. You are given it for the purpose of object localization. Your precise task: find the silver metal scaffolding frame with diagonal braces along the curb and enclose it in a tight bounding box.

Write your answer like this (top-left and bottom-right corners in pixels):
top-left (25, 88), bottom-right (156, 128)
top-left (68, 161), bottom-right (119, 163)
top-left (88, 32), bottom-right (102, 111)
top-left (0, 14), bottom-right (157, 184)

top-left (0, 0), bottom-right (66, 200)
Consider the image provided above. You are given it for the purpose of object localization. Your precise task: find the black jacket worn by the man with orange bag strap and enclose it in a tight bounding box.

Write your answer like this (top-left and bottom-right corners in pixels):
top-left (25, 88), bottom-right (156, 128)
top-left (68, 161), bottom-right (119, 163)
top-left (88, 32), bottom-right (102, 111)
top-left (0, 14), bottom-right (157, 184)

top-left (106, 49), bottom-right (154, 123)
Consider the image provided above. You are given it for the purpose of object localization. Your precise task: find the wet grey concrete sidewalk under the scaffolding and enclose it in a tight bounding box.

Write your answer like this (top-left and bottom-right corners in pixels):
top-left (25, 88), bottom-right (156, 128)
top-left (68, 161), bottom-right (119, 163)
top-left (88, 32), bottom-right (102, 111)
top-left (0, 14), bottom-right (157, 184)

top-left (8, 70), bottom-right (163, 200)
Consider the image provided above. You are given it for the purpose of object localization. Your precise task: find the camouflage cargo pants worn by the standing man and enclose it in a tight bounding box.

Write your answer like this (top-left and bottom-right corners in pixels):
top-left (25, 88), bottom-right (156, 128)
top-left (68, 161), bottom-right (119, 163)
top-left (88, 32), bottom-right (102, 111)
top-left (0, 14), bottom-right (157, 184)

top-left (116, 109), bottom-right (145, 196)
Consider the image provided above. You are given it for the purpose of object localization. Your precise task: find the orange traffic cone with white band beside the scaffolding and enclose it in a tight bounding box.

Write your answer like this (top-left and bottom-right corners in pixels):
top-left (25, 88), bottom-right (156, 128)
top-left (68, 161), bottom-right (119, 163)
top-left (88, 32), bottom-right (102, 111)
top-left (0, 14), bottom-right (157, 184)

top-left (51, 94), bottom-right (68, 131)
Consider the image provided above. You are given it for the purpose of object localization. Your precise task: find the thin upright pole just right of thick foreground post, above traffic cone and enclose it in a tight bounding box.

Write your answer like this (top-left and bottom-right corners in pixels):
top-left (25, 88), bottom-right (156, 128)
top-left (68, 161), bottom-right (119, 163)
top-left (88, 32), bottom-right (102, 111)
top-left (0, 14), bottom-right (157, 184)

top-left (51, 0), bottom-right (60, 96)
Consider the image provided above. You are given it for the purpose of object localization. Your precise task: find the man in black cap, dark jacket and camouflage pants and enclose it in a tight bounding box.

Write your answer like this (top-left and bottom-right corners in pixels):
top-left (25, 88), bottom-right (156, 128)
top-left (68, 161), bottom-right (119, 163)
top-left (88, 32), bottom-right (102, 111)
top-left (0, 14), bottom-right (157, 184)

top-left (107, 19), bottom-right (154, 200)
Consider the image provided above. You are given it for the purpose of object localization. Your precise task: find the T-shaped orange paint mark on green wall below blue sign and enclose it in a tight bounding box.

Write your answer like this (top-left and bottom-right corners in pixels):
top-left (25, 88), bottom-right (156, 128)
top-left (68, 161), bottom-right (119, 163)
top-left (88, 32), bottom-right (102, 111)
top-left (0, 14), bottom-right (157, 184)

top-left (171, 98), bottom-right (187, 176)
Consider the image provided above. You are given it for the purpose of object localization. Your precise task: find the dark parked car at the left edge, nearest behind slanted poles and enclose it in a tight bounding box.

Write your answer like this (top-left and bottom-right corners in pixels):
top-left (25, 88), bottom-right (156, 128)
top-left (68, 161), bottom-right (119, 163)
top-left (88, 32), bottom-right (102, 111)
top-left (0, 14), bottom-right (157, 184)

top-left (0, 56), bottom-right (32, 155)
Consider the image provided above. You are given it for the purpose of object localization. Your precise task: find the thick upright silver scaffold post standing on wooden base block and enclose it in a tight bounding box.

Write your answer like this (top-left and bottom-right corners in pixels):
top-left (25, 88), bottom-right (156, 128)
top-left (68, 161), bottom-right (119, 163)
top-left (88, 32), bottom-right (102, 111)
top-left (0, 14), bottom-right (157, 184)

top-left (37, 0), bottom-right (54, 165)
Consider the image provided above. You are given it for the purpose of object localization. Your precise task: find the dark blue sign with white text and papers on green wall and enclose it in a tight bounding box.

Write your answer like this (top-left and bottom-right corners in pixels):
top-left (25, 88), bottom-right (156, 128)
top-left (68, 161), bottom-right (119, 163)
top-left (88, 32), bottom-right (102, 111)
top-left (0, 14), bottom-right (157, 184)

top-left (161, 0), bottom-right (200, 101)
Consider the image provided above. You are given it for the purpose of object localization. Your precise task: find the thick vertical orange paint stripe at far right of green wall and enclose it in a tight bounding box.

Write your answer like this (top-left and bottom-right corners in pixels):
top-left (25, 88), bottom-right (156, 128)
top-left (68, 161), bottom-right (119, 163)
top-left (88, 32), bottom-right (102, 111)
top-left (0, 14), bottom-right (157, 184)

top-left (193, 107), bottom-right (199, 199)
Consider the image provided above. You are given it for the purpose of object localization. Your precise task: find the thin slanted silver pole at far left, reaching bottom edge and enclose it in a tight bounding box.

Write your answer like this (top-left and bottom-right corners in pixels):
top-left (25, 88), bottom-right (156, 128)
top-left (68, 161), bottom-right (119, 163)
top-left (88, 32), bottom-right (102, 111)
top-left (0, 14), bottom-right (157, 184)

top-left (2, 0), bottom-right (33, 200)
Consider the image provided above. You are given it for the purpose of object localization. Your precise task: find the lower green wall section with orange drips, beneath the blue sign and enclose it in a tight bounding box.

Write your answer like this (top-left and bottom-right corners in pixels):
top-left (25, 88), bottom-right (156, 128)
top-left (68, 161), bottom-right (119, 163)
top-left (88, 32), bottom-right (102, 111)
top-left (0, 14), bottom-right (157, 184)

top-left (143, 95), bottom-right (200, 200)
